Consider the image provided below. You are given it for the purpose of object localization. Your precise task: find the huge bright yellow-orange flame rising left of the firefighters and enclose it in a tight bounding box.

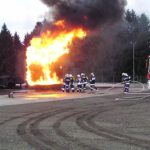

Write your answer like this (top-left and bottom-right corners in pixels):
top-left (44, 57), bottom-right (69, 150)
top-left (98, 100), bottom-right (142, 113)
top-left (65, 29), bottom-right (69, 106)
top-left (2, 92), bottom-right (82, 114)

top-left (26, 20), bottom-right (86, 86)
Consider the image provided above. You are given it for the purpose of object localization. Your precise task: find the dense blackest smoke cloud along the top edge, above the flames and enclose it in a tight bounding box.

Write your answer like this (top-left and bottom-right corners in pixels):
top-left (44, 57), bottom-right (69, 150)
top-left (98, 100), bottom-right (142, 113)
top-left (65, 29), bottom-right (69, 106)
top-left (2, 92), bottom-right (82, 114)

top-left (41, 0), bottom-right (126, 28)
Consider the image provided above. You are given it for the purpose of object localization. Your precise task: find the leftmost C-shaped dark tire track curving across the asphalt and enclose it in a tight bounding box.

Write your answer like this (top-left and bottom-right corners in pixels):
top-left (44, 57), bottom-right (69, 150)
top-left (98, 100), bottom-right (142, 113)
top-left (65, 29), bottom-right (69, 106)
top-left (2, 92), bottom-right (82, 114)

top-left (17, 108), bottom-right (72, 150)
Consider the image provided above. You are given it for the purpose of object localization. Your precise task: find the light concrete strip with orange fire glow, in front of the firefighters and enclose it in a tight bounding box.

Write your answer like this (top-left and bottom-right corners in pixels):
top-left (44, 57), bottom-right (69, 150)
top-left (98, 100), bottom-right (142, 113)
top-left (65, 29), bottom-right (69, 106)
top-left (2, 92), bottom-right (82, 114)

top-left (0, 90), bottom-right (123, 106)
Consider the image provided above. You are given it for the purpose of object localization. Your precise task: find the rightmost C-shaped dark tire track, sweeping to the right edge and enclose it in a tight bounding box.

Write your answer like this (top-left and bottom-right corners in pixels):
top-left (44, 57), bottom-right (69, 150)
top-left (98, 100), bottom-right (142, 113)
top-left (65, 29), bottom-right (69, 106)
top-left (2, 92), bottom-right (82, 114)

top-left (76, 97), bottom-right (150, 149)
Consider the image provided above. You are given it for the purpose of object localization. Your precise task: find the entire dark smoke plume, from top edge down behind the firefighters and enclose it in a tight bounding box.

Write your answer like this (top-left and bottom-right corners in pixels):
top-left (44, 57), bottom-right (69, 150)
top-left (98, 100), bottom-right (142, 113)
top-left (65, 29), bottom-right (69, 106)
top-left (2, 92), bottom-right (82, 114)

top-left (37, 0), bottom-right (127, 82)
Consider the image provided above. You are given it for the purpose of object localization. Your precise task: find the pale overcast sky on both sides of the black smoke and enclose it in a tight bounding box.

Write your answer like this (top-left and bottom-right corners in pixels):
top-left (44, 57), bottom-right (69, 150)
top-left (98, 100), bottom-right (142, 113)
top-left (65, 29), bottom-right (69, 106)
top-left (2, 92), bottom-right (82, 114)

top-left (0, 0), bottom-right (150, 39)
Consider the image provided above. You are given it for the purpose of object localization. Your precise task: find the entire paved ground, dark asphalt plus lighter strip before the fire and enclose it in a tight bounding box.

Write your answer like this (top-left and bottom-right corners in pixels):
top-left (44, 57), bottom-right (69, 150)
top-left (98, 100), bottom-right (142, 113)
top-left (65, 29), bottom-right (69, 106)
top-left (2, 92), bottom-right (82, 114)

top-left (0, 88), bottom-right (150, 150)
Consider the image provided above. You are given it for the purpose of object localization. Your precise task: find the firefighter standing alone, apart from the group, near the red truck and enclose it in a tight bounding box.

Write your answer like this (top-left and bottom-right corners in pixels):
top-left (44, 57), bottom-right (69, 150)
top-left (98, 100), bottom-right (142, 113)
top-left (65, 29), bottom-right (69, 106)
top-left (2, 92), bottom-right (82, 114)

top-left (122, 73), bottom-right (131, 93)
